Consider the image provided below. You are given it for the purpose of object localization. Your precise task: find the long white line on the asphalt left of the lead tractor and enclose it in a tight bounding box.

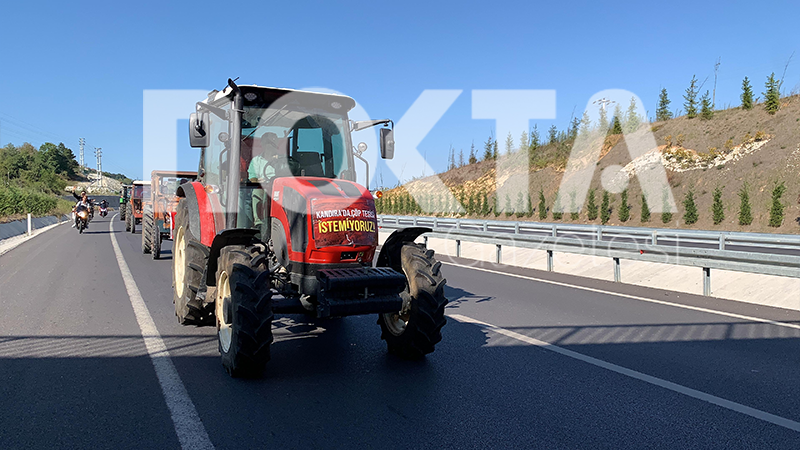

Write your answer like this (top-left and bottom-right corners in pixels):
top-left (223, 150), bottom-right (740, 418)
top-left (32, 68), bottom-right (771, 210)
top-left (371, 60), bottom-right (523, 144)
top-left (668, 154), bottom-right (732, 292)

top-left (108, 214), bottom-right (214, 450)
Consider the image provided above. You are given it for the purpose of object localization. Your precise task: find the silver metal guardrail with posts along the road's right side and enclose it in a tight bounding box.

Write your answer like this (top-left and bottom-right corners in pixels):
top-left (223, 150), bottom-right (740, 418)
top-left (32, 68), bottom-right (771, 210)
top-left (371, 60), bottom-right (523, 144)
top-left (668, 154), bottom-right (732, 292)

top-left (378, 215), bottom-right (800, 295)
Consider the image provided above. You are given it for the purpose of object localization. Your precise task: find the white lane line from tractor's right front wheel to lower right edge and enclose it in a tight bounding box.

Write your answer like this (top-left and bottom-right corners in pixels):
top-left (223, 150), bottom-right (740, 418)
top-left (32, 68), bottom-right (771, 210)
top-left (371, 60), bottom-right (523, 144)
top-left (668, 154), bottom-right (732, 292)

top-left (448, 314), bottom-right (800, 431)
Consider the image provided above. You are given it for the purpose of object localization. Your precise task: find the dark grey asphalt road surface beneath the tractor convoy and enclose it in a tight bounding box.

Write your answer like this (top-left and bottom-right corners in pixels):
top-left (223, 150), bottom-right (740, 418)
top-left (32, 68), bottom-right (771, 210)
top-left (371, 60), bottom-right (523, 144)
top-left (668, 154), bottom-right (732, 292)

top-left (0, 217), bottom-right (800, 449)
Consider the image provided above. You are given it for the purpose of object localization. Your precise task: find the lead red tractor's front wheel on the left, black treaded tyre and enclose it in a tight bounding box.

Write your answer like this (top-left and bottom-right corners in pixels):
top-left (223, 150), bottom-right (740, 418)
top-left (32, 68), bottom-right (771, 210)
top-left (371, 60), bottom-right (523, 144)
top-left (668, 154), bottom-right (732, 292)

top-left (215, 245), bottom-right (273, 377)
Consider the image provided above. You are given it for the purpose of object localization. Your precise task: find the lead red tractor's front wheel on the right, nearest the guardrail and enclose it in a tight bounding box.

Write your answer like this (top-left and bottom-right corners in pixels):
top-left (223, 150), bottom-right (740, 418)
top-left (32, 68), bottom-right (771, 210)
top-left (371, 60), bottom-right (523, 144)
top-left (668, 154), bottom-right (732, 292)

top-left (378, 243), bottom-right (447, 359)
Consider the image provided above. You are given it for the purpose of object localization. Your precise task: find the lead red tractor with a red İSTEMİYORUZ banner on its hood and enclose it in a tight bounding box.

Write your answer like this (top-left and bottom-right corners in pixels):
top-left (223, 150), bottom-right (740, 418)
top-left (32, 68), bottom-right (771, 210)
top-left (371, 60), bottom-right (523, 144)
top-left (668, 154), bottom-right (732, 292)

top-left (173, 80), bottom-right (447, 377)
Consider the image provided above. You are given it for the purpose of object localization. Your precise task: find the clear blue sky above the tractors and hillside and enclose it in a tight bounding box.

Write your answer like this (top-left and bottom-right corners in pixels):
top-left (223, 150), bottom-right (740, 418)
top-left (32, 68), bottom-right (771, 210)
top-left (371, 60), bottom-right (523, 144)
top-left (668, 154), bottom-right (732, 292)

top-left (0, 1), bottom-right (800, 183)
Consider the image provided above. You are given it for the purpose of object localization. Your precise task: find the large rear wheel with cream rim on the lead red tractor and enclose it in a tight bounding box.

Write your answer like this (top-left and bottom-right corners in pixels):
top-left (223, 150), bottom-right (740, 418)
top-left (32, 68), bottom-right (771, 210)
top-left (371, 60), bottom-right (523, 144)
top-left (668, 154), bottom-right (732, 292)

top-left (172, 199), bottom-right (213, 325)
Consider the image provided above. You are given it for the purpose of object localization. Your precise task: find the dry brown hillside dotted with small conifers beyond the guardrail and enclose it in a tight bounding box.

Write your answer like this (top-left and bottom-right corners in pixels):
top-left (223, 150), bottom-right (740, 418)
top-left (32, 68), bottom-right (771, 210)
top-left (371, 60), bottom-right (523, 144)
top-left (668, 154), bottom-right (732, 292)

top-left (378, 96), bottom-right (800, 233)
